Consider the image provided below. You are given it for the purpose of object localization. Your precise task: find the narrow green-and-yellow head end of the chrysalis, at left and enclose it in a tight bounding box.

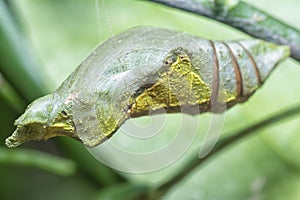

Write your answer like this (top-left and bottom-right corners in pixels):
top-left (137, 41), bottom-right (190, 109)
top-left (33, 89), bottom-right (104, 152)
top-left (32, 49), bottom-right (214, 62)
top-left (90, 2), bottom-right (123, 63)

top-left (5, 94), bottom-right (76, 147)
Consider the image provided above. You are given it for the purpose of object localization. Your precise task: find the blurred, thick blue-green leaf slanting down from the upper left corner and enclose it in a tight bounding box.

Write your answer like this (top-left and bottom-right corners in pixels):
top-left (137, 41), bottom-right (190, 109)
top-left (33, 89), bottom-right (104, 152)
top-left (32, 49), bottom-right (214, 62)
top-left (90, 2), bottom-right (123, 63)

top-left (0, 1), bottom-right (47, 102)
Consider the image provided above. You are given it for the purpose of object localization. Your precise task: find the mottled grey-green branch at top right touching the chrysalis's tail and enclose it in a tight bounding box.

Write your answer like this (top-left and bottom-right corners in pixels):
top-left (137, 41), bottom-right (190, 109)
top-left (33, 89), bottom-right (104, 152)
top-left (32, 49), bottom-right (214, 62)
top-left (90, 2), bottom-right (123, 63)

top-left (147, 0), bottom-right (300, 61)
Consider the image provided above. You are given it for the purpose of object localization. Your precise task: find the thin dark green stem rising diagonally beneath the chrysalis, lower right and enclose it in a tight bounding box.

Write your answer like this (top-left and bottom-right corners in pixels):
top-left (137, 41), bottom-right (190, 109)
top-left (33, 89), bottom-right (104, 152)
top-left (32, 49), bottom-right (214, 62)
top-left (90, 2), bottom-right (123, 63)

top-left (157, 105), bottom-right (300, 196)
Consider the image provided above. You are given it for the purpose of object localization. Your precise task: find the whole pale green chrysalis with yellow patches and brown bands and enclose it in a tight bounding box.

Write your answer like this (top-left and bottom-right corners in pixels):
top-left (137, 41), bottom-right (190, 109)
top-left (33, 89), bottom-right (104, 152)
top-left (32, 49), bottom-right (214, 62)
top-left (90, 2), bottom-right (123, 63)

top-left (6, 27), bottom-right (289, 147)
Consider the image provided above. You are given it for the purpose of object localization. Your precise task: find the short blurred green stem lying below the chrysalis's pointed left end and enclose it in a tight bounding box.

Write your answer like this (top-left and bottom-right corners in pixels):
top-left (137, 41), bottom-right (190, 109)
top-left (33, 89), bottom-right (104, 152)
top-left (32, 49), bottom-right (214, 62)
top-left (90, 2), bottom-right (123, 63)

top-left (0, 148), bottom-right (76, 176)
